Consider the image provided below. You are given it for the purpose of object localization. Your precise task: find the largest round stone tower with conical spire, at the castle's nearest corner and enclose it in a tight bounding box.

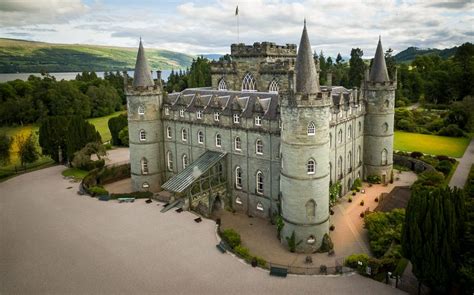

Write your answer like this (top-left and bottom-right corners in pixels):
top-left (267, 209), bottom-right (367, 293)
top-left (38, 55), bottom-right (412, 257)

top-left (280, 22), bottom-right (330, 253)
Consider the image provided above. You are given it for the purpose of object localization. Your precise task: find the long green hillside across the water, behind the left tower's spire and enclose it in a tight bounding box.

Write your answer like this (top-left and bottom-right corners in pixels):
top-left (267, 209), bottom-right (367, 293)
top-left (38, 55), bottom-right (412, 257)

top-left (0, 38), bottom-right (193, 73)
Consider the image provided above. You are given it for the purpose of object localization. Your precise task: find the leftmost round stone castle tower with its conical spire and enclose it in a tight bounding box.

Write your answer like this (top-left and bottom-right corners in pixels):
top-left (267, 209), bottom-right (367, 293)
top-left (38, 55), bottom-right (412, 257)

top-left (125, 40), bottom-right (164, 191)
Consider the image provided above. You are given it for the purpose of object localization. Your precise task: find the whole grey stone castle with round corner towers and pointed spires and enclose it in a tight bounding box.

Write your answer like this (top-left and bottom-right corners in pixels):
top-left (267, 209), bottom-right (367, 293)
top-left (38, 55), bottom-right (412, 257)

top-left (125, 24), bottom-right (396, 252)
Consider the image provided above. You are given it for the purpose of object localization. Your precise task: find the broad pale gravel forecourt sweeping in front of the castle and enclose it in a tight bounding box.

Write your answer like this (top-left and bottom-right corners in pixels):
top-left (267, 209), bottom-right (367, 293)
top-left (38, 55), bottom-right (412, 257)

top-left (0, 166), bottom-right (403, 294)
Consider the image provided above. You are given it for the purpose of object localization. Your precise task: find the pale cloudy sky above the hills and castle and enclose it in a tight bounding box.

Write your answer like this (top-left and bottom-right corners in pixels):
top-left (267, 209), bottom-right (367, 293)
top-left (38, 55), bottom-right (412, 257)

top-left (0, 0), bottom-right (474, 57)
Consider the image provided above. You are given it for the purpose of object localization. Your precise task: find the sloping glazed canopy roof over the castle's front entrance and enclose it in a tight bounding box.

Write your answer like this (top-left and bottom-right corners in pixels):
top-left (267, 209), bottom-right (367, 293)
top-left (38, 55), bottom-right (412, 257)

top-left (161, 151), bottom-right (226, 193)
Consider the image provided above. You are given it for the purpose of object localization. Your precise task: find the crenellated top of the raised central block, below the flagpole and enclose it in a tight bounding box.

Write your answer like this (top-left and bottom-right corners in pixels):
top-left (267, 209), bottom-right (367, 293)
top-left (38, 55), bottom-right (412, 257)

top-left (230, 42), bottom-right (296, 58)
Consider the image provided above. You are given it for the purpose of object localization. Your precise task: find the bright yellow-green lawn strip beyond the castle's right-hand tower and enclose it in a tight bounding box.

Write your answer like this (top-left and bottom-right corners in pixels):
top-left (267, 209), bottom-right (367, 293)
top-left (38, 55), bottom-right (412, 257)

top-left (394, 131), bottom-right (470, 158)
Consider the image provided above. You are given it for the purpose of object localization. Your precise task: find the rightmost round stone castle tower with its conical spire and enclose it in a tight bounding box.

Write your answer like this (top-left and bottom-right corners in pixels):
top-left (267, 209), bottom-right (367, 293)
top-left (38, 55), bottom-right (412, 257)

top-left (362, 38), bottom-right (397, 183)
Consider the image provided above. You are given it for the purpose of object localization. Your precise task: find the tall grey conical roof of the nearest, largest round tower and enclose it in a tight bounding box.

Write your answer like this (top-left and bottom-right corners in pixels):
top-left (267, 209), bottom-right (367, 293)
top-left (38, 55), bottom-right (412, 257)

top-left (295, 20), bottom-right (320, 94)
